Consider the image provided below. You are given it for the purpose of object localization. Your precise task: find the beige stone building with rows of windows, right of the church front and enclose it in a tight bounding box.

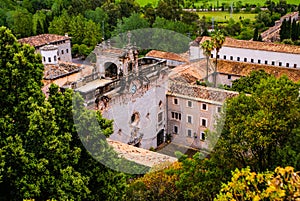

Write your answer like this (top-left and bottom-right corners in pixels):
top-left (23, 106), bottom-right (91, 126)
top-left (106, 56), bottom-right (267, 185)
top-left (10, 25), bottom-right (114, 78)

top-left (167, 82), bottom-right (238, 150)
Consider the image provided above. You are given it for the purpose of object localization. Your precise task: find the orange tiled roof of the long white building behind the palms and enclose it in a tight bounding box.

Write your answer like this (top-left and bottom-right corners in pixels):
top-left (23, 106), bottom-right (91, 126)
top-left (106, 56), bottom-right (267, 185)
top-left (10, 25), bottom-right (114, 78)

top-left (200, 36), bottom-right (300, 54)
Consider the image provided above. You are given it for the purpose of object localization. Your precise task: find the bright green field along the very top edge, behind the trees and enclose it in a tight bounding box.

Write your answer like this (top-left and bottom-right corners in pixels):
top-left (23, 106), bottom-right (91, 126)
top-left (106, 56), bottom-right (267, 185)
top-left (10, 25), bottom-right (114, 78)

top-left (136, 0), bottom-right (300, 6)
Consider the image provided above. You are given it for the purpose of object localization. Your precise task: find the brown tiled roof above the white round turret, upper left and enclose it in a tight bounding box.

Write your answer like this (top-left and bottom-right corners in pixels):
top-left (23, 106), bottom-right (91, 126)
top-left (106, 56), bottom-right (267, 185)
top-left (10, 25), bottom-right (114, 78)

top-left (18, 34), bottom-right (70, 47)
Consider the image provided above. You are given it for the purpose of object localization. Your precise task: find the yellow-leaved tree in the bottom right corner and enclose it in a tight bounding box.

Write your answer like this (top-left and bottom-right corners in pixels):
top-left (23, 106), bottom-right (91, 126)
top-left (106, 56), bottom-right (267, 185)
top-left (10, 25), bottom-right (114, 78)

top-left (215, 166), bottom-right (300, 201)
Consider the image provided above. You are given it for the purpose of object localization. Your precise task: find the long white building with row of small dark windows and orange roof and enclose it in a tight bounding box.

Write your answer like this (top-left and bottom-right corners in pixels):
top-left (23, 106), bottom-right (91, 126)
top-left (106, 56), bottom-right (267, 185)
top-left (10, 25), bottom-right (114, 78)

top-left (190, 36), bottom-right (300, 68)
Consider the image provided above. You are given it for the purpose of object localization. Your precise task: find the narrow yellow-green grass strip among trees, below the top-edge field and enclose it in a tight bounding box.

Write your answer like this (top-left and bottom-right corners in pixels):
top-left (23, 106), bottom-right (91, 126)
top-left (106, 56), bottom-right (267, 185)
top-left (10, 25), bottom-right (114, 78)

top-left (198, 12), bottom-right (257, 22)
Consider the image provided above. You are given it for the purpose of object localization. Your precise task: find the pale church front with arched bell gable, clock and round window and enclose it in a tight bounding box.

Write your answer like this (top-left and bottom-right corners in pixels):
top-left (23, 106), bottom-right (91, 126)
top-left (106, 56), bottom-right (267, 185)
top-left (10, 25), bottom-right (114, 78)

top-left (94, 37), bottom-right (168, 149)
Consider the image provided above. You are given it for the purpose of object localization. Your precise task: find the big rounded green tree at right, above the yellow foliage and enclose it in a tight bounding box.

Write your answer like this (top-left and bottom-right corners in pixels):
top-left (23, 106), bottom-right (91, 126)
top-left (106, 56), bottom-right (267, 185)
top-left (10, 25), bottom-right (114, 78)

top-left (215, 73), bottom-right (300, 171)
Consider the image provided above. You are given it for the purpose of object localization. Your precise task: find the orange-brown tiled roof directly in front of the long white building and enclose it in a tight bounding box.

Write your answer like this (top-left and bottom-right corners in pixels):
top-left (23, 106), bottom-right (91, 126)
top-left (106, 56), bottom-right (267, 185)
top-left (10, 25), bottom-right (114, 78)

top-left (218, 60), bottom-right (300, 82)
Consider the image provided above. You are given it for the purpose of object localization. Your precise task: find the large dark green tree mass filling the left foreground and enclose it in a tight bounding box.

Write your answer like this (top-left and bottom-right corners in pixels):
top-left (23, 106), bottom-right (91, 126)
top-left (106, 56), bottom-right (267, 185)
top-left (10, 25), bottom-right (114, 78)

top-left (0, 27), bottom-right (137, 200)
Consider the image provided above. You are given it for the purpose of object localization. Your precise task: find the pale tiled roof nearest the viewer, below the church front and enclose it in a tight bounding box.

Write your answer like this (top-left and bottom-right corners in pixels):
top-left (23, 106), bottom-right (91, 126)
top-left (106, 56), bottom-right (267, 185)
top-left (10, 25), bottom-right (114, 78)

top-left (107, 139), bottom-right (177, 167)
